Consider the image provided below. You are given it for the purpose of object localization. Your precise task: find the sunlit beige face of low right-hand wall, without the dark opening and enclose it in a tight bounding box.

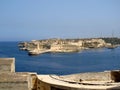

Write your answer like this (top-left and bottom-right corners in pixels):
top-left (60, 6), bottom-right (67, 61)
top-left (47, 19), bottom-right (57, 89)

top-left (61, 71), bottom-right (112, 82)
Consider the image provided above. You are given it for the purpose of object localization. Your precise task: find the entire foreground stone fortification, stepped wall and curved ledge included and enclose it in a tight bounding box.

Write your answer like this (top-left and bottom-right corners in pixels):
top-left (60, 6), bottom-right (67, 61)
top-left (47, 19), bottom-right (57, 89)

top-left (0, 58), bottom-right (120, 90)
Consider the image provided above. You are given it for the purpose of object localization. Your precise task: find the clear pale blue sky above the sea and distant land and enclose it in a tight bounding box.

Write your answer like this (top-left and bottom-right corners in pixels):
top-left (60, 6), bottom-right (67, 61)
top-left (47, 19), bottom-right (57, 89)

top-left (0, 0), bottom-right (120, 41)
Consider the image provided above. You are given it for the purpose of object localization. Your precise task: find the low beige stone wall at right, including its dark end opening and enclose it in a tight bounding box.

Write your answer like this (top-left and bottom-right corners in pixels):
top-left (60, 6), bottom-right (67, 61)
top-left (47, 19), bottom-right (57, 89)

top-left (61, 70), bottom-right (120, 82)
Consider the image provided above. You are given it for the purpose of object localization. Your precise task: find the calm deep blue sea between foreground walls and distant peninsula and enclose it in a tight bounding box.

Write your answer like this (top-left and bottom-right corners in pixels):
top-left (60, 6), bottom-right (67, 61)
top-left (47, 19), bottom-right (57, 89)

top-left (0, 42), bottom-right (120, 75)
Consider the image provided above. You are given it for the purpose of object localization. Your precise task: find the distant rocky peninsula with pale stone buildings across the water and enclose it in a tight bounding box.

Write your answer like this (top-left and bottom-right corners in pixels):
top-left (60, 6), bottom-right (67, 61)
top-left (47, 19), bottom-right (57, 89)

top-left (18, 37), bottom-right (120, 55)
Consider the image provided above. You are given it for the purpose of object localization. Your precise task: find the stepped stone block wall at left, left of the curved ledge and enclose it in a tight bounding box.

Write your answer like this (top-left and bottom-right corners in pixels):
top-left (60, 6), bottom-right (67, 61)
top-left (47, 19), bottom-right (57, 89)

top-left (0, 58), bottom-right (37, 90)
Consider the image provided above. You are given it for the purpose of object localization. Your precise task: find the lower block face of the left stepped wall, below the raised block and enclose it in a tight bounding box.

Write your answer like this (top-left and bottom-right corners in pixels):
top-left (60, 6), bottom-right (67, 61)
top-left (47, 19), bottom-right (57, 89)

top-left (0, 73), bottom-right (32, 90)
